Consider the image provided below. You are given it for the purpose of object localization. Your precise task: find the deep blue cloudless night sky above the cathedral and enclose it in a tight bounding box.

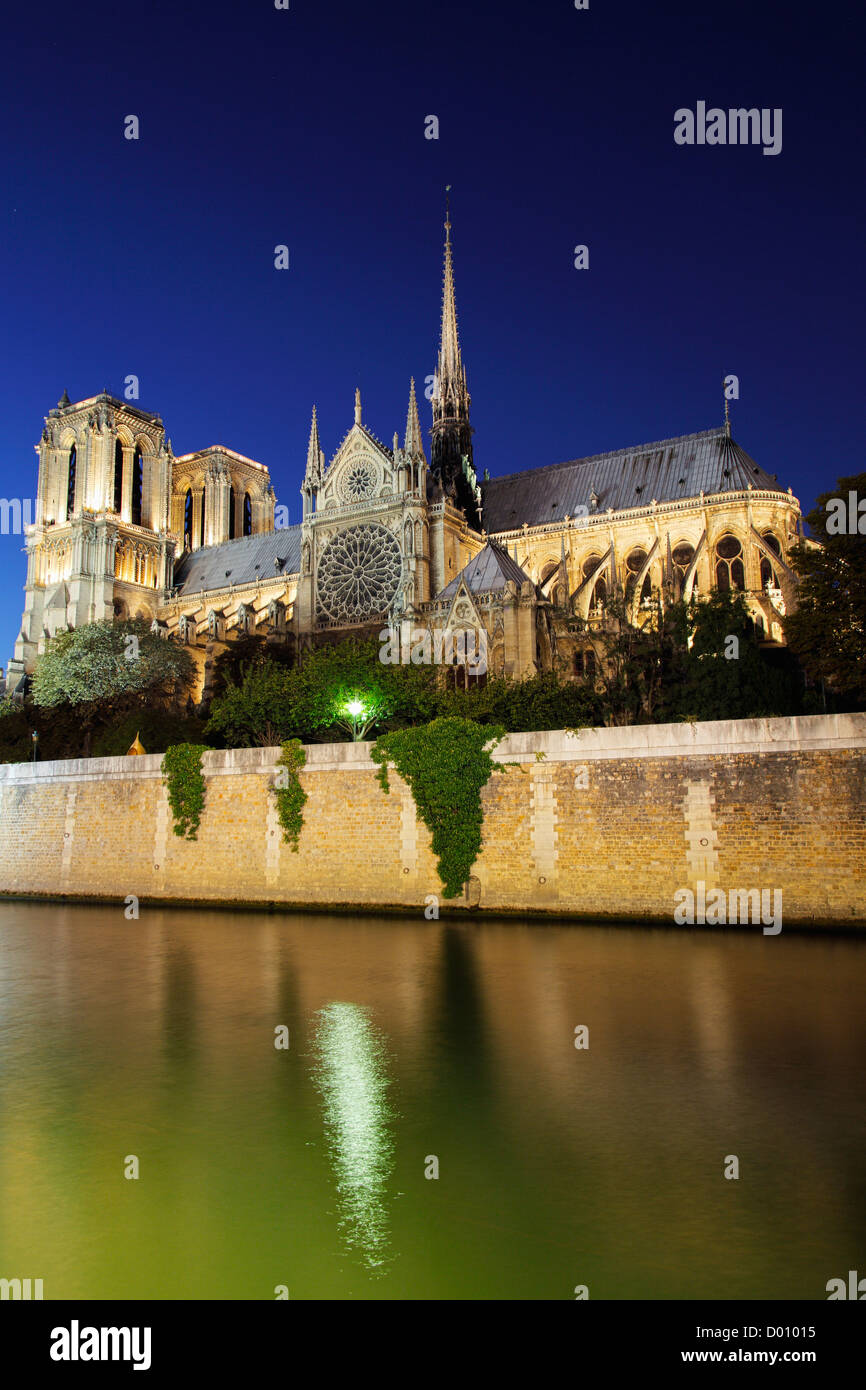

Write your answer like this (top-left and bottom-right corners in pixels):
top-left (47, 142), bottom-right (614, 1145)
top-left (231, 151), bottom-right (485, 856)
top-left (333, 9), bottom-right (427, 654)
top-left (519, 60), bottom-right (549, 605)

top-left (0, 0), bottom-right (865, 664)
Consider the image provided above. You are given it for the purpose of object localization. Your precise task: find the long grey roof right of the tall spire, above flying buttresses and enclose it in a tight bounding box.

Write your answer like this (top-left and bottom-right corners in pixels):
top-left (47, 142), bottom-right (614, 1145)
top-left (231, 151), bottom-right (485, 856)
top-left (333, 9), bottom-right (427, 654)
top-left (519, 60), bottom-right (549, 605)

top-left (481, 427), bottom-right (784, 532)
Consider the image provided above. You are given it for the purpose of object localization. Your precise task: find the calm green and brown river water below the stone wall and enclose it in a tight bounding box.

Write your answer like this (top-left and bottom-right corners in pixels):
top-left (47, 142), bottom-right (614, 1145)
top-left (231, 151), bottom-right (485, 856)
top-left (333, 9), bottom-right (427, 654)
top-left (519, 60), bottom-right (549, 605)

top-left (0, 902), bottom-right (866, 1300)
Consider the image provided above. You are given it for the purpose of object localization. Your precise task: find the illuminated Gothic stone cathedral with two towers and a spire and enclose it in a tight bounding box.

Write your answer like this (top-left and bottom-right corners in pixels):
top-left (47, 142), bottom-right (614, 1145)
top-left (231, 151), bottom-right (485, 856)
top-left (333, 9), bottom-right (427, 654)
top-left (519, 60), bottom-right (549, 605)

top-left (7, 209), bottom-right (802, 699)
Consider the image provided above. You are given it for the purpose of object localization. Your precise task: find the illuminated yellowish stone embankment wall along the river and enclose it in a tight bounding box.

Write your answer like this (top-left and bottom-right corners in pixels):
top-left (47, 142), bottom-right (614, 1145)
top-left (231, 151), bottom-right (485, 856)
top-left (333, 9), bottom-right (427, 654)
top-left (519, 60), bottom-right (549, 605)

top-left (0, 714), bottom-right (866, 927)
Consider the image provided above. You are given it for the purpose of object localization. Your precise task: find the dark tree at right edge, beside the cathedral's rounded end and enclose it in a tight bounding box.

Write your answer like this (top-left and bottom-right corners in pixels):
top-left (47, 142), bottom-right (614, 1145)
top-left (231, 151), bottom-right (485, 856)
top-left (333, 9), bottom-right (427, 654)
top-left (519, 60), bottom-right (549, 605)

top-left (784, 473), bottom-right (866, 705)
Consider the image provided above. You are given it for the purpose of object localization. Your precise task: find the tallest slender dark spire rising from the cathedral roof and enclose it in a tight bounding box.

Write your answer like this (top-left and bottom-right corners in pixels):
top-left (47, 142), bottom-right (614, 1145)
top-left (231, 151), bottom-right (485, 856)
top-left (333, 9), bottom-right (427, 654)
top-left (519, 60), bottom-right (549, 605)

top-left (430, 201), bottom-right (481, 531)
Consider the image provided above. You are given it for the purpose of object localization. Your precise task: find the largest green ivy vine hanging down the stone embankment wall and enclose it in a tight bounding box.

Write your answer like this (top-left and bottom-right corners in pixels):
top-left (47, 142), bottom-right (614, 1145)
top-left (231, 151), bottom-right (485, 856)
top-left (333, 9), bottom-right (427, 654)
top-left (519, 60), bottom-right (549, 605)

top-left (370, 719), bottom-right (505, 898)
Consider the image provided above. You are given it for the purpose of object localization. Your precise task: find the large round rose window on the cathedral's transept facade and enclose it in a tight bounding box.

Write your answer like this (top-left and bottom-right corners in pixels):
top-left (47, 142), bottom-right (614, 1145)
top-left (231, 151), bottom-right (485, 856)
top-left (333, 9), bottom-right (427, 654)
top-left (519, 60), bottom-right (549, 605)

top-left (317, 525), bottom-right (403, 623)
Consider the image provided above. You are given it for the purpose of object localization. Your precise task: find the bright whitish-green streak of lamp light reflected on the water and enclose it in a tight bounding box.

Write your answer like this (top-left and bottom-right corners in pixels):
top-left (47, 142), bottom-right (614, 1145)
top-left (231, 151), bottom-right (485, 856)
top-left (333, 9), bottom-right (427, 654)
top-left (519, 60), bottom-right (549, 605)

top-left (313, 1004), bottom-right (393, 1269)
